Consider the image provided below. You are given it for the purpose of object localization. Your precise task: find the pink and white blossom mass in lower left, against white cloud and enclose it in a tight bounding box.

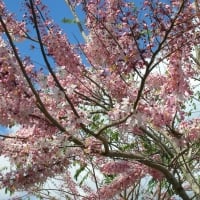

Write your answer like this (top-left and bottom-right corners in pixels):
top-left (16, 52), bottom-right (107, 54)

top-left (1, 129), bottom-right (75, 190)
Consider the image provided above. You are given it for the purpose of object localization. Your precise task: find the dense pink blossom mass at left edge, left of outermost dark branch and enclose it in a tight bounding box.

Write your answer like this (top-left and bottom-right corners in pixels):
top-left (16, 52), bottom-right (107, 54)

top-left (0, 38), bottom-right (35, 125)
